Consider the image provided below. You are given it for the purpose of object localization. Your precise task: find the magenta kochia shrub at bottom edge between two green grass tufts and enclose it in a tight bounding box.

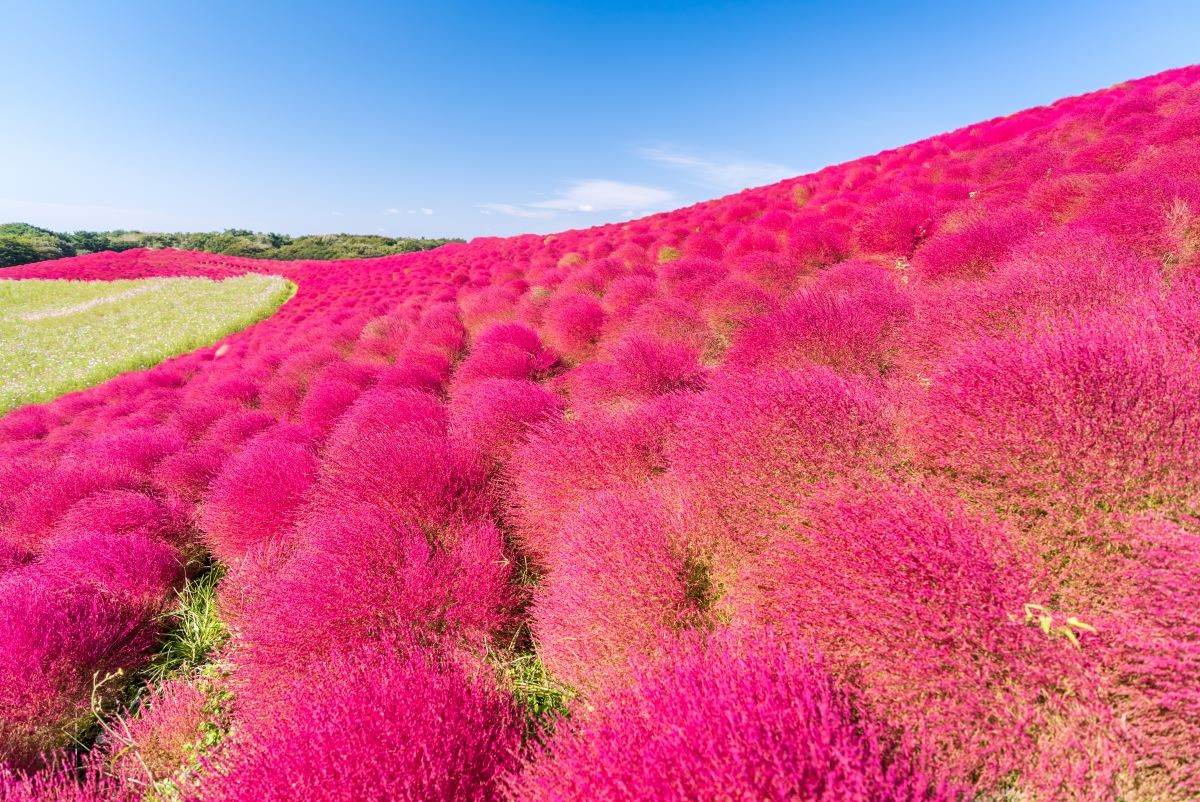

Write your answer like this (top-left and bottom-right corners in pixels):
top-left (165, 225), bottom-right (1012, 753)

top-left (201, 641), bottom-right (521, 802)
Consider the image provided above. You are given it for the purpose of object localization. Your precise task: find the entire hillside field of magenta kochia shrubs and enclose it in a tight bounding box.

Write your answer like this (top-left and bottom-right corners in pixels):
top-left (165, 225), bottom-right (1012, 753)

top-left (0, 67), bottom-right (1200, 802)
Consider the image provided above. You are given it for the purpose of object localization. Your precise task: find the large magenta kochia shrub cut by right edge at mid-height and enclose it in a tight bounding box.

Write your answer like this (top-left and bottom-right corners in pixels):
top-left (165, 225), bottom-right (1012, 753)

top-left (913, 305), bottom-right (1200, 509)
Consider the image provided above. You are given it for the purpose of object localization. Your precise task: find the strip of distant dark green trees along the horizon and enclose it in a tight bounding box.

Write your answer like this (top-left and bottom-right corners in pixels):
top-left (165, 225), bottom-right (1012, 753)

top-left (0, 223), bottom-right (463, 268)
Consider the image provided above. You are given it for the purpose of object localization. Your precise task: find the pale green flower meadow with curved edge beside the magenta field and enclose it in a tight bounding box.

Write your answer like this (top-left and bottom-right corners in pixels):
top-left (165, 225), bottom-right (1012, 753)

top-left (0, 274), bottom-right (295, 413)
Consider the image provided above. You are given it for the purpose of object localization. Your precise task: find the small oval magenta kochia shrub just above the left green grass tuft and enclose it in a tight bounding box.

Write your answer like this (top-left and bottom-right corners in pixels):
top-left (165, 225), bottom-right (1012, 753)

top-left (199, 424), bottom-right (320, 563)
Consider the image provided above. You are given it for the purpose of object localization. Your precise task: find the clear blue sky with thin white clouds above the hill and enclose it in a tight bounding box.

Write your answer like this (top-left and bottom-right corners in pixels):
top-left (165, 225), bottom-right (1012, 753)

top-left (0, 0), bottom-right (1200, 238)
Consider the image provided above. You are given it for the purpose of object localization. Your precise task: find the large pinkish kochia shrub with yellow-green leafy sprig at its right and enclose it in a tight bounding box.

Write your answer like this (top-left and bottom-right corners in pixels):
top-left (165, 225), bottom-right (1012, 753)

top-left (725, 484), bottom-right (1124, 798)
